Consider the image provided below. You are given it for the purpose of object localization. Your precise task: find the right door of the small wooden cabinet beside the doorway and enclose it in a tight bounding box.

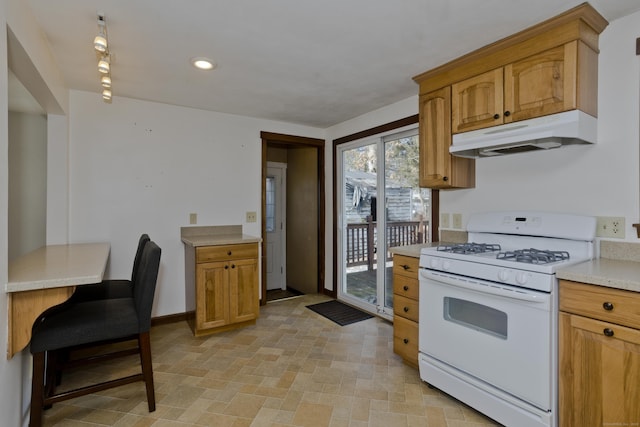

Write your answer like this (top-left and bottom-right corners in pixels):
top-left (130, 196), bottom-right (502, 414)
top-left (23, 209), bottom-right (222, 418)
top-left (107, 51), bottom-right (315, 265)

top-left (229, 259), bottom-right (259, 323)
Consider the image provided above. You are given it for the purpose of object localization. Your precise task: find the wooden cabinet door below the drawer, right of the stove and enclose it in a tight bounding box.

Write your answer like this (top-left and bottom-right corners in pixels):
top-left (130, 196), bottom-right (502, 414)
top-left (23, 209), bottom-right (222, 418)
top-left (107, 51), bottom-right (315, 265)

top-left (560, 313), bottom-right (640, 427)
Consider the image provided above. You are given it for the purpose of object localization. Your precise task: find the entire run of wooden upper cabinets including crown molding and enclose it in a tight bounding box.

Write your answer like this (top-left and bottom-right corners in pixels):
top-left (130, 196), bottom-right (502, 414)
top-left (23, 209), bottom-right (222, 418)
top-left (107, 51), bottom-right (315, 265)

top-left (414, 3), bottom-right (608, 188)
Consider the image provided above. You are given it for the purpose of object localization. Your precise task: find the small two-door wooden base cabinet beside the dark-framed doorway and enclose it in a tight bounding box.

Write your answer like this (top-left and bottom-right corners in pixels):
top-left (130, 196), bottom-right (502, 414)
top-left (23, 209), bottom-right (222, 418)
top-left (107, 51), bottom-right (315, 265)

top-left (184, 243), bottom-right (260, 336)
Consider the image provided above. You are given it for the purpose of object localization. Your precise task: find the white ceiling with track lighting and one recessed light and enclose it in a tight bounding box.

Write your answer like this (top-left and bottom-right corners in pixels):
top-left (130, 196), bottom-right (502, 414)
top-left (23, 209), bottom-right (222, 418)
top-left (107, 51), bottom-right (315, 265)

top-left (13, 0), bottom-right (640, 128)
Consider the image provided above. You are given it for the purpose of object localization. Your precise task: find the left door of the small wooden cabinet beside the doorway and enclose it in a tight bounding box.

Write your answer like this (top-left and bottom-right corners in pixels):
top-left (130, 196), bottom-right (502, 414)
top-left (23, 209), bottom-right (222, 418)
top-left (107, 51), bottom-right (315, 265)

top-left (196, 262), bottom-right (229, 329)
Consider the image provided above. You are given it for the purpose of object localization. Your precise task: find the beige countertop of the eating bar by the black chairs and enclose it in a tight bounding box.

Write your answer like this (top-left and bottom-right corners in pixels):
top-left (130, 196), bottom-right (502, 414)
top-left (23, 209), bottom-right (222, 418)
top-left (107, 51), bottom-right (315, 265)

top-left (5, 243), bottom-right (111, 292)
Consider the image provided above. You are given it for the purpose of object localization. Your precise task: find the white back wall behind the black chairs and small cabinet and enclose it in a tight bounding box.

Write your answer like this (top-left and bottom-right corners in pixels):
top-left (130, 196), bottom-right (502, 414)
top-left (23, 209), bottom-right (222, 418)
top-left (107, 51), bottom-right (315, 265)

top-left (69, 91), bottom-right (324, 316)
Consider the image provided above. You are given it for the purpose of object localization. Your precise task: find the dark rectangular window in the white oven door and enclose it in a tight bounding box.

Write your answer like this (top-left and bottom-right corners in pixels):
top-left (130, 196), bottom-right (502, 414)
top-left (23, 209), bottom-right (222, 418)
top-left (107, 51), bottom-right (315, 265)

top-left (444, 297), bottom-right (507, 340)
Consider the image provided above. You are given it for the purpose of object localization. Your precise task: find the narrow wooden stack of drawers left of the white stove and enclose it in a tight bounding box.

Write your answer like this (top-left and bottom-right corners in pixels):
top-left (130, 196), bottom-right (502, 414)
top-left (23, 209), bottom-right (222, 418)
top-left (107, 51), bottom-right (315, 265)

top-left (393, 255), bottom-right (419, 367)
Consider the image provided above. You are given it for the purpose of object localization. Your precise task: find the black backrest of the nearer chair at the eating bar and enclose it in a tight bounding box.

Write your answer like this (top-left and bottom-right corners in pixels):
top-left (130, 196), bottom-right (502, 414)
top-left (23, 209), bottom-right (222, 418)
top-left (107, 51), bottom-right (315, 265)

top-left (133, 241), bottom-right (161, 333)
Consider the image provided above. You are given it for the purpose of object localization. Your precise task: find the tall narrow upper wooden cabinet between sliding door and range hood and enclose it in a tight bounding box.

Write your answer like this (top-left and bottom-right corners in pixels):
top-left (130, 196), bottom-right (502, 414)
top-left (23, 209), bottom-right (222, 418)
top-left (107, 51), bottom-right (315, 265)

top-left (419, 87), bottom-right (475, 189)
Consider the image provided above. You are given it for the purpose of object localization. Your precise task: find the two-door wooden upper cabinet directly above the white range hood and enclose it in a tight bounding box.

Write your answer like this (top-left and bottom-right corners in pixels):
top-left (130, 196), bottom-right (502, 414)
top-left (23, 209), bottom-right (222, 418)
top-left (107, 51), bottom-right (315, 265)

top-left (451, 40), bottom-right (598, 133)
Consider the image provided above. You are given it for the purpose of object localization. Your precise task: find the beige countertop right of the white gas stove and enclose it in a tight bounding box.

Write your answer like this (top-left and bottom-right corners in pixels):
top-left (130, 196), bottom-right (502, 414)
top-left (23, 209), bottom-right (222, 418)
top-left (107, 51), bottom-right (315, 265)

top-left (556, 258), bottom-right (640, 292)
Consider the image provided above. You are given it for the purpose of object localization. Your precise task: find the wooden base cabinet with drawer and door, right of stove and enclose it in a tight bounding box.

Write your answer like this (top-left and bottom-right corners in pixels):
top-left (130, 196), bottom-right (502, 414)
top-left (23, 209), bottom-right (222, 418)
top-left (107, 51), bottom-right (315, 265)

top-left (559, 281), bottom-right (640, 427)
